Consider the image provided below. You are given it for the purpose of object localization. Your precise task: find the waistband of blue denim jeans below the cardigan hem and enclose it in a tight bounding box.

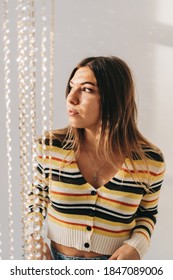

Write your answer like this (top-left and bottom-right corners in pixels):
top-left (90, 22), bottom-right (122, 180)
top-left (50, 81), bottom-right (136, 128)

top-left (51, 246), bottom-right (109, 260)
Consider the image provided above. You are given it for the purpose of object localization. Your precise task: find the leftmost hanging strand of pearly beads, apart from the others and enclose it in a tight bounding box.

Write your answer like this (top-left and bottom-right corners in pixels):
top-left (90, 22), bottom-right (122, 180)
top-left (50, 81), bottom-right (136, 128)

top-left (0, 0), bottom-right (14, 259)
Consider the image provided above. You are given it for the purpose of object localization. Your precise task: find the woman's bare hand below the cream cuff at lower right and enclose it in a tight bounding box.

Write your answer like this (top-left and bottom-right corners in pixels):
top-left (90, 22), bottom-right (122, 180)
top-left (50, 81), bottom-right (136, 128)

top-left (109, 244), bottom-right (140, 260)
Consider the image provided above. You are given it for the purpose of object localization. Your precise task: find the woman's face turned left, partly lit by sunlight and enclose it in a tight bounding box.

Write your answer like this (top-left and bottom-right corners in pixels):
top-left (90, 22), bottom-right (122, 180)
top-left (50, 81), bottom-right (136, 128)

top-left (67, 67), bottom-right (100, 131)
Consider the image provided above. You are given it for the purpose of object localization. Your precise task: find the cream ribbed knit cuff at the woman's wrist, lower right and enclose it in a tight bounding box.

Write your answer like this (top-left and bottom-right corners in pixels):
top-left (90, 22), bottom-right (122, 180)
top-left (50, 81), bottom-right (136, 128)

top-left (124, 233), bottom-right (149, 259)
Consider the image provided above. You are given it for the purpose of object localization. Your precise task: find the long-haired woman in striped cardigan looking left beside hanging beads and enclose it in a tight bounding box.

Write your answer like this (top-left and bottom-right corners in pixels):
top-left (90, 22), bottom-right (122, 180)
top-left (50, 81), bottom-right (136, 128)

top-left (29, 57), bottom-right (165, 260)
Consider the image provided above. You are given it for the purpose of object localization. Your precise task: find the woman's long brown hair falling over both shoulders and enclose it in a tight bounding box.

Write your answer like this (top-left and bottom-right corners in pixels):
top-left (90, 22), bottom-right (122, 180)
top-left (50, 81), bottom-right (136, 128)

top-left (49, 56), bottom-right (160, 188)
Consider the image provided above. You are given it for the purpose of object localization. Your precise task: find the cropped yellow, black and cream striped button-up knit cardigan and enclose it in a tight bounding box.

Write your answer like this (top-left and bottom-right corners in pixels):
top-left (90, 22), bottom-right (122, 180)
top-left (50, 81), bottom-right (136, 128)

top-left (29, 140), bottom-right (165, 258)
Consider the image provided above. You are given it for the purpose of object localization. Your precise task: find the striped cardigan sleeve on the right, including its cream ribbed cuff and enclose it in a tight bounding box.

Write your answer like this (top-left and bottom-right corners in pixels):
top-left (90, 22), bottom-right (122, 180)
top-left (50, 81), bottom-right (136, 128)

top-left (124, 158), bottom-right (165, 258)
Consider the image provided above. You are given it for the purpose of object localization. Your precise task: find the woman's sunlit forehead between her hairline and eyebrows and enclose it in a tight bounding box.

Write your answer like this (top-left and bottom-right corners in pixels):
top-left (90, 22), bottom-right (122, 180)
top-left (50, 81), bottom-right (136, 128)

top-left (71, 67), bottom-right (97, 85)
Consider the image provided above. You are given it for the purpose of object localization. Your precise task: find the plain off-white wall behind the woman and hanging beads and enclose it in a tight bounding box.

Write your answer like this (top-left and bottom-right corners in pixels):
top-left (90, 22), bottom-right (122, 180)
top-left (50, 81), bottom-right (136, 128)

top-left (0, 0), bottom-right (173, 260)
